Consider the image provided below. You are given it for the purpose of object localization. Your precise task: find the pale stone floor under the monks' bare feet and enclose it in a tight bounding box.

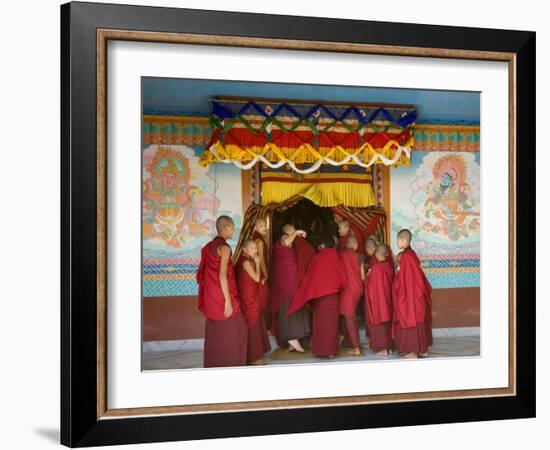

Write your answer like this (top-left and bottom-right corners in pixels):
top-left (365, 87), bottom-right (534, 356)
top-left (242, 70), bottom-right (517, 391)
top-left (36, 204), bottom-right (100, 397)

top-left (142, 334), bottom-right (480, 371)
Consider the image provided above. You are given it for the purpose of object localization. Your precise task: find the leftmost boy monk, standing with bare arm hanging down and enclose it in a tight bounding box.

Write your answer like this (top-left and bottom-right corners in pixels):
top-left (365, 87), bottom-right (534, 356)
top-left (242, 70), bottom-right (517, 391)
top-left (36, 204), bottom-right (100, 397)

top-left (197, 216), bottom-right (247, 367)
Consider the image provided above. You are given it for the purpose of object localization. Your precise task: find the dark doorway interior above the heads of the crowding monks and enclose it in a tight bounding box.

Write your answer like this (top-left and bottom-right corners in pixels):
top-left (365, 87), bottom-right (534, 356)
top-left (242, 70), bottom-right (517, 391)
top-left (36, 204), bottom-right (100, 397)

top-left (272, 198), bottom-right (338, 248)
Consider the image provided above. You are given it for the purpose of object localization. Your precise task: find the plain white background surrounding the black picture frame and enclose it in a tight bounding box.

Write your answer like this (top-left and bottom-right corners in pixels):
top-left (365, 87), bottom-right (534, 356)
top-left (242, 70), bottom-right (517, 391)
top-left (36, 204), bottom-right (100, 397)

top-left (0, 0), bottom-right (550, 450)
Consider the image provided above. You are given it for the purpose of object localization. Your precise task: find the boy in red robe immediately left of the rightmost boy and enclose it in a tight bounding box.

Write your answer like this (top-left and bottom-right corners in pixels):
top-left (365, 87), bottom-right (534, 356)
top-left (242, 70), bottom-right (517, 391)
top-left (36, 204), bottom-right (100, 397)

top-left (365, 244), bottom-right (393, 356)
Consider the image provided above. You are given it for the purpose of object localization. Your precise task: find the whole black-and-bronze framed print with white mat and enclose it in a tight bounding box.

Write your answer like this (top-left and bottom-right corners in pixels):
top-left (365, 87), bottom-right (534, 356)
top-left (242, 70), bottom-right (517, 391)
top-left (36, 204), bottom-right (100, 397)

top-left (61, 3), bottom-right (535, 447)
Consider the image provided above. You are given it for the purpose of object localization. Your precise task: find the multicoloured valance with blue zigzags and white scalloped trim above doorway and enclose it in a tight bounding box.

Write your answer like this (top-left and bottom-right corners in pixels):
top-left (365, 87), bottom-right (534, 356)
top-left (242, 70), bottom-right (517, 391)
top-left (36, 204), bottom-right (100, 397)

top-left (201, 99), bottom-right (417, 174)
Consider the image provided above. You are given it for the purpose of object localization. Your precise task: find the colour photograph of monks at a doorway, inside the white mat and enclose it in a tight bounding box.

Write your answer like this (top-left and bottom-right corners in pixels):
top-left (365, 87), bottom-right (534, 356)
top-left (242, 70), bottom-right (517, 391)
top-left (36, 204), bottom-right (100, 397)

top-left (141, 77), bottom-right (481, 371)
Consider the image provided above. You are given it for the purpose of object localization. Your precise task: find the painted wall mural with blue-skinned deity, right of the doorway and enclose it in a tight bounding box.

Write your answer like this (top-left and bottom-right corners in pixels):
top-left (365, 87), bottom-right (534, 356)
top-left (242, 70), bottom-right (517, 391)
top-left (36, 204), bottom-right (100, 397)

top-left (391, 151), bottom-right (481, 288)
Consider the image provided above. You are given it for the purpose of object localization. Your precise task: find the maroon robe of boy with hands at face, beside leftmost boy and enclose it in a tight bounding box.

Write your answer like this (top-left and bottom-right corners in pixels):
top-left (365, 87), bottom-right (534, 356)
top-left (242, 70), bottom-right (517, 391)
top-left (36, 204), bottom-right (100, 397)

top-left (237, 253), bottom-right (271, 363)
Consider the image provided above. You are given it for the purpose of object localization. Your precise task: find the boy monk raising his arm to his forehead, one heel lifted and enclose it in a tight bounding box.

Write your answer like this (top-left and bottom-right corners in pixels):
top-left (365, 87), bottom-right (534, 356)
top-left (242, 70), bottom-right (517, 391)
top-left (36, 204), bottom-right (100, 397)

top-left (270, 224), bottom-right (311, 352)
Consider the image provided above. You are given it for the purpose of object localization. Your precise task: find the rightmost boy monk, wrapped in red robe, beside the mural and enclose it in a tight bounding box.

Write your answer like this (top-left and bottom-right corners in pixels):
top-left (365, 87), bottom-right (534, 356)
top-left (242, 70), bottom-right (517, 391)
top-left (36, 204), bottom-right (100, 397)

top-left (392, 229), bottom-right (433, 358)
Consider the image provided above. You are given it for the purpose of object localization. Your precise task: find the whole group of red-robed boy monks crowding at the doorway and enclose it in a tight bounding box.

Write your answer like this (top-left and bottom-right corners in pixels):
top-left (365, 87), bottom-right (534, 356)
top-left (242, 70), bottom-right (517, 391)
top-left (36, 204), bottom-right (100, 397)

top-left (197, 216), bottom-right (432, 367)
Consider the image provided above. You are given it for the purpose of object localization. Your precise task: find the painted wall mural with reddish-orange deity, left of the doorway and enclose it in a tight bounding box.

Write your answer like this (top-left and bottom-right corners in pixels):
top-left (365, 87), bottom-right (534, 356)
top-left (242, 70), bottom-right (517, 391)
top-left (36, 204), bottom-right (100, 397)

top-left (142, 145), bottom-right (243, 297)
